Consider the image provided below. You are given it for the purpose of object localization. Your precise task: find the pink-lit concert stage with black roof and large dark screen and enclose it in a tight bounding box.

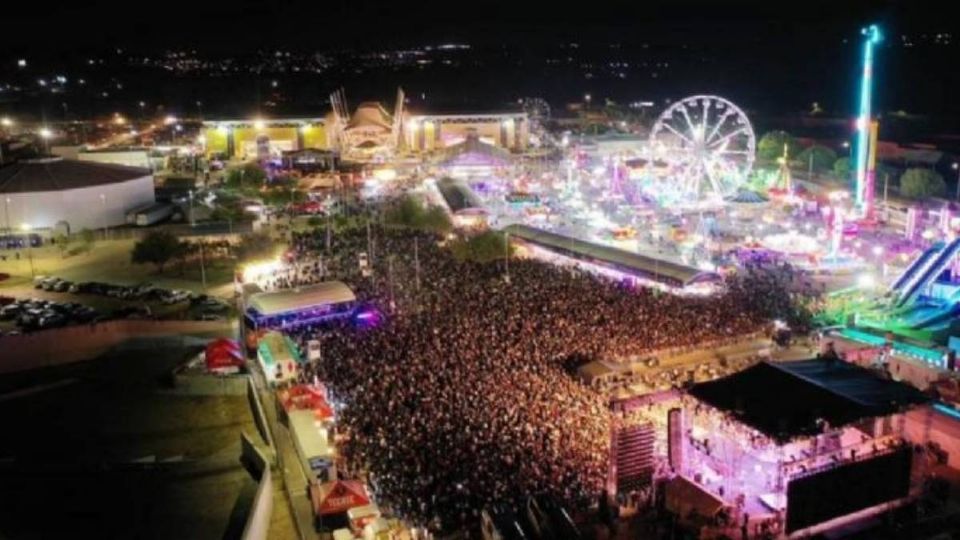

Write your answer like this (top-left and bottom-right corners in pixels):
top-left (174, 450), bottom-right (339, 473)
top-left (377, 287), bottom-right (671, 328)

top-left (668, 359), bottom-right (927, 537)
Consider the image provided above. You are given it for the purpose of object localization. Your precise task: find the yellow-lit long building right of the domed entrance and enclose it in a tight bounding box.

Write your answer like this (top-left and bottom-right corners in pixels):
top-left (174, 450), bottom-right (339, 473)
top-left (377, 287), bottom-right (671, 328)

top-left (403, 112), bottom-right (530, 152)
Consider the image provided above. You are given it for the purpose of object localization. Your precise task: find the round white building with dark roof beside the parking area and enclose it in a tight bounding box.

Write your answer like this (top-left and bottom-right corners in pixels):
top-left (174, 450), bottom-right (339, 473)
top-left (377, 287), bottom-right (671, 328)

top-left (0, 157), bottom-right (155, 232)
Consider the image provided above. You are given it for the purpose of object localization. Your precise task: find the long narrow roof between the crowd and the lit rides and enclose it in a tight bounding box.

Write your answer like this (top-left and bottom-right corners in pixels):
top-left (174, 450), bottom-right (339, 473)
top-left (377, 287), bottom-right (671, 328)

top-left (503, 224), bottom-right (717, 286)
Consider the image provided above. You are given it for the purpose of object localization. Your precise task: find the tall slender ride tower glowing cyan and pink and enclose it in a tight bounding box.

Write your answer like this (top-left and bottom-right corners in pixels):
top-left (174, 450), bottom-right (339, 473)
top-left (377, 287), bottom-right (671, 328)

top-left (856, 24), bottom-right (882, 218)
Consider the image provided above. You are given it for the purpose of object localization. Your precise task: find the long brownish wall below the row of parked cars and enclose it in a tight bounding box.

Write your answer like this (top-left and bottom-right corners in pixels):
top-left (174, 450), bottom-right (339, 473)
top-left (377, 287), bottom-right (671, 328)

top-left (0, 320), bottom-right (233, 373)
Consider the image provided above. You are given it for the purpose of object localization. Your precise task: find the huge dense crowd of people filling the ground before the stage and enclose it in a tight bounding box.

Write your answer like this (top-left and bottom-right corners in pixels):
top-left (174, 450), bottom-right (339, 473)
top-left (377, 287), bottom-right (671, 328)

top-left (282, 224), bottom-right (800, 529)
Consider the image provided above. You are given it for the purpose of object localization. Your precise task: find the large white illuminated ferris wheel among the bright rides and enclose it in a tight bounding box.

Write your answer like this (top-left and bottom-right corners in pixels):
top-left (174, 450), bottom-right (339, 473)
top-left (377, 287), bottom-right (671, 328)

top-left (650, 95), bottom-right (757, 202)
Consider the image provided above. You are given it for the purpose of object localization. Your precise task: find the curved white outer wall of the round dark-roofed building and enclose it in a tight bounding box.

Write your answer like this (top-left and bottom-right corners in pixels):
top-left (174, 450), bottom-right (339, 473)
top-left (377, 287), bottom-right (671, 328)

top-left (4, 175), bottom-right (155, 232)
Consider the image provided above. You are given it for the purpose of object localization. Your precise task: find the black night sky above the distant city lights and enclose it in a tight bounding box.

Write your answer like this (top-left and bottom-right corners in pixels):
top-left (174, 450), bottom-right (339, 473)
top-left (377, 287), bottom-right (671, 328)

top-left (3, 0), bottom-right (924, 54)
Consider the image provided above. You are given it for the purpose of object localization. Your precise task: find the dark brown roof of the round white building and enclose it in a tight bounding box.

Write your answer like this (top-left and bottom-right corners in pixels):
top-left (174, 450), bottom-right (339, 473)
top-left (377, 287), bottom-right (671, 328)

top-left (0, 157), bottom-right (151, 193)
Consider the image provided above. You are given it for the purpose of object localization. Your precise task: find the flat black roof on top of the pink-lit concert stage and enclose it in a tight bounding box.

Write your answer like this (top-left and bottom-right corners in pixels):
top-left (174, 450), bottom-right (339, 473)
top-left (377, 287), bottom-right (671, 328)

top-left (690, 359), bottom-right (927, 442)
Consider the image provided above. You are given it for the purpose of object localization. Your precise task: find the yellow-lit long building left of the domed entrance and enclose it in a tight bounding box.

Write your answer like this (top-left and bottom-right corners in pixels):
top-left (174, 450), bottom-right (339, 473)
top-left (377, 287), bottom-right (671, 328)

top-left (200, 118), bottom-right (331, 159)
